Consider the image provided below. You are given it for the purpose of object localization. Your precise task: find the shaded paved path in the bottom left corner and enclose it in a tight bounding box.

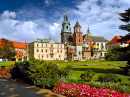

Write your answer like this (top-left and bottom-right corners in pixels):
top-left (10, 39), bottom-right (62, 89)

top-left (0, 76), bottom-right (65, 97)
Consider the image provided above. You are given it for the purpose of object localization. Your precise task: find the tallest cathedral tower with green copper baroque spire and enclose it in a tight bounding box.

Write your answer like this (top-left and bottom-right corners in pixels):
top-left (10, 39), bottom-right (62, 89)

top-left (61, 14), bottom-right (71, 44)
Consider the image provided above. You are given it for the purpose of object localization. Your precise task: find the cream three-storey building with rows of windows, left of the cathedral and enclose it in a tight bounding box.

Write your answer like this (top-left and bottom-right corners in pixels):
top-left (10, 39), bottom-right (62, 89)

top-left (27, 39), bottom-right (64, 60)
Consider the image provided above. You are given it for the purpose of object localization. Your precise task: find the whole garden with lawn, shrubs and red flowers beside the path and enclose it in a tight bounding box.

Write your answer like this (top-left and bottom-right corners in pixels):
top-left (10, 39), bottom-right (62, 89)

top-left (0, 58), bottom-right (130, 97)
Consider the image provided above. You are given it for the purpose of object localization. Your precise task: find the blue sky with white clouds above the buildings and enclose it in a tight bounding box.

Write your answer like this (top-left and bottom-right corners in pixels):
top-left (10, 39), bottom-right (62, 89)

top-left (0, 0), bottom-right (130, 42)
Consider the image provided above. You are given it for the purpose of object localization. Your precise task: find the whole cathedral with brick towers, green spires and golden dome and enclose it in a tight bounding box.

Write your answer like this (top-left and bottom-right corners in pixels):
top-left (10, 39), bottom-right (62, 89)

top-left (61, 14), bottom-right (108, 60)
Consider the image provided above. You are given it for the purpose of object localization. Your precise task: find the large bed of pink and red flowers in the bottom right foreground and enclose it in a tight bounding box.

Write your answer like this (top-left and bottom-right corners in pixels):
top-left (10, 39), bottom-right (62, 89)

top-left (52, 82), bottom-right (130, 97)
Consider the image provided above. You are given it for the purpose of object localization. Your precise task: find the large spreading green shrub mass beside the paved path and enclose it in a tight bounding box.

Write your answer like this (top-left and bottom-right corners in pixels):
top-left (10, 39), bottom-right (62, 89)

top-left (11, 59), bottom-right (59, 88)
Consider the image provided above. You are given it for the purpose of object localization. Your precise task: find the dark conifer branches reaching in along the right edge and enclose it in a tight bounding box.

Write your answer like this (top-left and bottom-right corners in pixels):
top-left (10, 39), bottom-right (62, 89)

top-left (118, 8), bottom-right (130, 75)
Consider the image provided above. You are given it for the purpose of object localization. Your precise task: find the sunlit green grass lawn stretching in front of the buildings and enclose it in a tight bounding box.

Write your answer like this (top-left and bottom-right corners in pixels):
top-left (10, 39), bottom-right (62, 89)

top-left (0, 60), bottom-right (130, 85)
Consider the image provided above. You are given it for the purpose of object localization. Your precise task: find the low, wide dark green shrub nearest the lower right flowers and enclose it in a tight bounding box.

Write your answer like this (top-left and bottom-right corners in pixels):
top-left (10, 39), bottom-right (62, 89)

top-left (98, 73), bottom-right (121, 83)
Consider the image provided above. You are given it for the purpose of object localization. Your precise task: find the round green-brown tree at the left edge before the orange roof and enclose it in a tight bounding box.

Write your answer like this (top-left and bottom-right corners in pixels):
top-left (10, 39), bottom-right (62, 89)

top-left (0, 38), bottom-right (16, 60)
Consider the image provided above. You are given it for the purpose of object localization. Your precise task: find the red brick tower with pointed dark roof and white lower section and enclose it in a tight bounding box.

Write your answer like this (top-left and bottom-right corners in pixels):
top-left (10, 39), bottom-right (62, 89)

top-left (73, 21), bottom-right (83, 60)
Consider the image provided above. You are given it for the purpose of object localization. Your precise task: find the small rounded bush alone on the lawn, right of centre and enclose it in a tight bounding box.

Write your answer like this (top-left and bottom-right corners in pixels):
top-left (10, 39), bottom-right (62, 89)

top-left (80, 69), bottom-right (95, 81)
